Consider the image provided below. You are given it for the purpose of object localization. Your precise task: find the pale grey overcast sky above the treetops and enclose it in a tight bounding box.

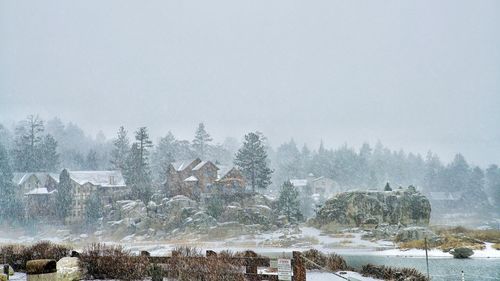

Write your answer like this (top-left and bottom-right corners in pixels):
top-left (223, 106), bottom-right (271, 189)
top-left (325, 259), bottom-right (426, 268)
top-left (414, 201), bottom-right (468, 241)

top-left (0, 0), bottom-right (500, 165)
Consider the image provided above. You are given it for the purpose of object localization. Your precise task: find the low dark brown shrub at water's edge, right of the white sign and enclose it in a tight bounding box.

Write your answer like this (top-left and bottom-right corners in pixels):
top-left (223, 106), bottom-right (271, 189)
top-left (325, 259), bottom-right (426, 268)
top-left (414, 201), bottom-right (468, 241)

top-left (361, 264), bottom-right (429, 281)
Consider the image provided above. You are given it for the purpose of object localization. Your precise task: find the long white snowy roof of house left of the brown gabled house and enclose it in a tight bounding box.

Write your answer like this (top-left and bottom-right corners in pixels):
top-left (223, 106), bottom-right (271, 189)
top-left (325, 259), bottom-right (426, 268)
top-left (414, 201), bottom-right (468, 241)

top-left (69, 171), bottom-right (125, 187)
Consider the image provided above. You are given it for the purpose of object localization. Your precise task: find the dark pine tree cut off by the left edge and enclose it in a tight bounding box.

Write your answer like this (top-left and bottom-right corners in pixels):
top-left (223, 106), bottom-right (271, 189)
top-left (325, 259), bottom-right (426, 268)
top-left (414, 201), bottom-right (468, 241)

top-left (0, 143), bottom-right (23, 223)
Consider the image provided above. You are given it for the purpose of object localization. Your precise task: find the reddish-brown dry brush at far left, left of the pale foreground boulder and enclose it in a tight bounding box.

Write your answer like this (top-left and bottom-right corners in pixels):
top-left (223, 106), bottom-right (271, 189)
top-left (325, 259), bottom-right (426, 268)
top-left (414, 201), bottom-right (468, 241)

top-left (0, 241), bottom-right (71, 271)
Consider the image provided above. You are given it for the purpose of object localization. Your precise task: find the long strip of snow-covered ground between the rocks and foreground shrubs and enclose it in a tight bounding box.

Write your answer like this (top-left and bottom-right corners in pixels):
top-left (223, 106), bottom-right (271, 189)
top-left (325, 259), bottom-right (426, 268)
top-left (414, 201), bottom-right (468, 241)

top-left (0, 223), bottom-right (500, 259)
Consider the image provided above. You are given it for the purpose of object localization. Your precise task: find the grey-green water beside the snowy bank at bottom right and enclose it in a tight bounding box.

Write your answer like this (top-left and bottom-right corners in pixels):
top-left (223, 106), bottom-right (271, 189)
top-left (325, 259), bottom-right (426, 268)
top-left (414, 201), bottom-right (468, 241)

top-left (342, 254), bottom-right (500, 281)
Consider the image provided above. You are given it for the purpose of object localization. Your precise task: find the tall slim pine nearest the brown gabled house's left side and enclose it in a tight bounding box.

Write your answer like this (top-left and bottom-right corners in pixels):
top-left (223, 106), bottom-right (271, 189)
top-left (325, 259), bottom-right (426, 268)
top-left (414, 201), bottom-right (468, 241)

top-left (127, 127), bottom-right (153, 203)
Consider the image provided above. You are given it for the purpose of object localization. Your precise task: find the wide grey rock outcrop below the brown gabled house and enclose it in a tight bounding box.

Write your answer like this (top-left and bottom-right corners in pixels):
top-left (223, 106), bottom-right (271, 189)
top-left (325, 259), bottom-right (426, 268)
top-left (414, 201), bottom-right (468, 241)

top-left (94, 194), bottom-right (277, 241)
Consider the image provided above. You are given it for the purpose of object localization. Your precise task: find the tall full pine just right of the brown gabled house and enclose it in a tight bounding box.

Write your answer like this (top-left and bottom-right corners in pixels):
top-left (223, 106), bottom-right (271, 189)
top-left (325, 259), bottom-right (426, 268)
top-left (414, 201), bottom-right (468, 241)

top-left (234, 133), bottom-right (273, 192)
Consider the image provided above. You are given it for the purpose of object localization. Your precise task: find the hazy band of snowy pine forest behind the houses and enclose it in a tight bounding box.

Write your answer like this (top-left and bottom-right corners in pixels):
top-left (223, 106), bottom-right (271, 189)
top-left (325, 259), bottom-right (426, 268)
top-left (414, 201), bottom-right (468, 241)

top-left (0, 115), bottom-right (500, 219)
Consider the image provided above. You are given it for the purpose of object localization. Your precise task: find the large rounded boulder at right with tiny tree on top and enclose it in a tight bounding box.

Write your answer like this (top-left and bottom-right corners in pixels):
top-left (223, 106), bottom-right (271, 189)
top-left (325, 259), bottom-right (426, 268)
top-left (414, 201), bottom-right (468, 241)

top-left (315, 189), bottom-right (431, 226)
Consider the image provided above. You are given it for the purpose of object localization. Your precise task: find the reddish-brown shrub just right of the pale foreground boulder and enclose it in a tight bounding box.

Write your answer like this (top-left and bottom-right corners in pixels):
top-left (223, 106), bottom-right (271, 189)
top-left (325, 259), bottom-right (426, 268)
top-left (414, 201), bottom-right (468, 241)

top-left (80, 243), bottom-right (149, 280)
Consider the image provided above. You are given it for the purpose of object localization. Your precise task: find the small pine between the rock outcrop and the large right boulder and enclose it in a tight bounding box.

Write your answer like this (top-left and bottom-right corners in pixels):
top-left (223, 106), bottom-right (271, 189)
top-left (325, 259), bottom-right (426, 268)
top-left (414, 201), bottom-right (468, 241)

top-left (278, 181), bottom-right (302, 222)
